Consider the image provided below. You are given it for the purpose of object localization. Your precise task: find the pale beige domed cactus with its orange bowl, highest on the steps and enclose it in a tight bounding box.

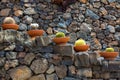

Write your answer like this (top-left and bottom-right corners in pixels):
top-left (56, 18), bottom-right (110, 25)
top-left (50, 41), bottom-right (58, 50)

top-left (2, 17), bottom-right (19, 30)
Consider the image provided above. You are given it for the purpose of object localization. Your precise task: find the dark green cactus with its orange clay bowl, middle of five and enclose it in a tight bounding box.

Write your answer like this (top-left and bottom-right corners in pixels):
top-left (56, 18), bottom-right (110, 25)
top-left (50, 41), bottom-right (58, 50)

top-left (53, 32), bottom-right (70, 44)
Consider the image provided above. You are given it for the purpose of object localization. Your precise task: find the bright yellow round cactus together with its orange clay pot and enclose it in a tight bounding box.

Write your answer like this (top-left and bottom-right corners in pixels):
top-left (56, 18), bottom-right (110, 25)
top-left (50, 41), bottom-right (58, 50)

top-left (74, 39), bottom-right (89, 52)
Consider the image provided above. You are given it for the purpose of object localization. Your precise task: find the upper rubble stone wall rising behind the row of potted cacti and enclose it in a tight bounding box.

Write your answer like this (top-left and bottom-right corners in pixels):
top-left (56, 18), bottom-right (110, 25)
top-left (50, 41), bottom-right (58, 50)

top-left (0, 0), bottom-right (120, 50)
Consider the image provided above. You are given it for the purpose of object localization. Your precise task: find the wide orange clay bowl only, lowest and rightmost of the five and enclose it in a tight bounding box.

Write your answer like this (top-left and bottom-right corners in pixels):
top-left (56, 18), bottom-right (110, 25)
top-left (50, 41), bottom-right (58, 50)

top-left (100, 52), bottom-right (118, 60)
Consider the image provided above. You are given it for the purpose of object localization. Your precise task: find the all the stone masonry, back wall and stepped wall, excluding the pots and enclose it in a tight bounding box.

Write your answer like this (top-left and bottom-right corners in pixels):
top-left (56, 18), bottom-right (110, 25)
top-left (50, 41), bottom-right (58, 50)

top-left (0, 0), bottom-right (120, 80)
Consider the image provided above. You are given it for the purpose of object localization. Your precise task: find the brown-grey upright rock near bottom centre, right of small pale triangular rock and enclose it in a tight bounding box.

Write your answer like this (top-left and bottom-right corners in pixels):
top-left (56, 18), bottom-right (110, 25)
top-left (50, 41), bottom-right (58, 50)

top-left (55, 65), bottom-right (67, 78)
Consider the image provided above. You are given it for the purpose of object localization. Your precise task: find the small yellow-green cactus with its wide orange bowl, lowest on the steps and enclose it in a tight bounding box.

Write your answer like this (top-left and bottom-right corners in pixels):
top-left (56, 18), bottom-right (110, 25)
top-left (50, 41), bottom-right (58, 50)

top-left (100, 47), bottom-right (118, 60)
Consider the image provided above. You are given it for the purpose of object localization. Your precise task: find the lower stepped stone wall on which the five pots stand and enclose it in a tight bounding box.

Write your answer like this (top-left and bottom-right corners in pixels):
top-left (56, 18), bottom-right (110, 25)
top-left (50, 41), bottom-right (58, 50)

top-left (0, 30), bottom-right (120, 80)
